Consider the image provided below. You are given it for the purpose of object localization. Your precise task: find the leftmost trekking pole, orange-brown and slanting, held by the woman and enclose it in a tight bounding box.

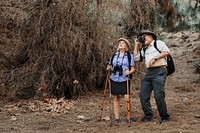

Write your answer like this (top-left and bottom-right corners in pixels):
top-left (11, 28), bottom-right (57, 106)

top-left (99, 70), bottom-right (110, 121)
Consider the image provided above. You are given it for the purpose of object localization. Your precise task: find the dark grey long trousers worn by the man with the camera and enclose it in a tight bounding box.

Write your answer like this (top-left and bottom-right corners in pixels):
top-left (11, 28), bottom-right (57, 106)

top-left (140, 68), bottom-right (169, 120)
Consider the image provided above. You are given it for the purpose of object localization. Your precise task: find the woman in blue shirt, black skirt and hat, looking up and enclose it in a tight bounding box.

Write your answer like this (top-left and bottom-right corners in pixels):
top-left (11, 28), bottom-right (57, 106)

top-left (108, 38), bottom-right (135, 123)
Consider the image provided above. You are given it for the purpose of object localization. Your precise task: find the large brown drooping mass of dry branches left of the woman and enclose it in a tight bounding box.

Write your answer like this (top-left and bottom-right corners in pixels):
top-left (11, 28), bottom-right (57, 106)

top-left (0, 0), bottom-right (111, 98)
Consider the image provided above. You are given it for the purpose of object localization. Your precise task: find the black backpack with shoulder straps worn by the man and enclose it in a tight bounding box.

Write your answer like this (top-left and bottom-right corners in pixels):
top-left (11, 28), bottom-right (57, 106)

top-left (140, 40), bottom-right (175, 76)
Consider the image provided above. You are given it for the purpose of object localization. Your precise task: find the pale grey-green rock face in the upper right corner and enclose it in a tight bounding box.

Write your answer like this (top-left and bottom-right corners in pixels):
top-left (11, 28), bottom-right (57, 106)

top-left (172, 0), bottom-right (200, 30)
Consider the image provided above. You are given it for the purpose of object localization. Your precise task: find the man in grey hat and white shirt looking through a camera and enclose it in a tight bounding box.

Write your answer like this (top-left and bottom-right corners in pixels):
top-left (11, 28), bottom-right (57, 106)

top-left (134, 30), bottom-right (170, 123)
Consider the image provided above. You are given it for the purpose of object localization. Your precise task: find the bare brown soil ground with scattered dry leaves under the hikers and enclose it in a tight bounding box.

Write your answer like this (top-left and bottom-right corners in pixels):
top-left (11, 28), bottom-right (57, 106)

top-left (0, 31), bottom-right (200, 133)
